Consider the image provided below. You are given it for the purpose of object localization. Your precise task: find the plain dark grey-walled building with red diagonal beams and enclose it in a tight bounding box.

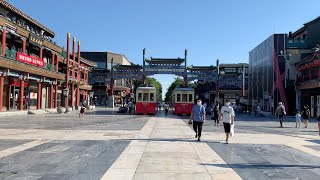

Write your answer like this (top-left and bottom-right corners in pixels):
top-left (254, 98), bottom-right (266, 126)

top-left (249, 34), bottom-right (296, 114)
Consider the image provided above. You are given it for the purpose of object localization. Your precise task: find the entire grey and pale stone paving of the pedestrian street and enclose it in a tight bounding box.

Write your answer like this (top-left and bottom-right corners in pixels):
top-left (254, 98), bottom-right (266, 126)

top-left (0, 109), bottom-right (320, 180)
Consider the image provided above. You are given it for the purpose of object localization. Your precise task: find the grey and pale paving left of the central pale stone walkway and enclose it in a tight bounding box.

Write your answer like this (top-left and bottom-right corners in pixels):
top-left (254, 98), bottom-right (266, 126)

top-left (0, 107), bottom-right (150, 180)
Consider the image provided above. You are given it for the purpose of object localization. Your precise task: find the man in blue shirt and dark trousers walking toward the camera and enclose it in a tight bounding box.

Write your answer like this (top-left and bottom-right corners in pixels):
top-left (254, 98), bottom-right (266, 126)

top-left (190, 99), bottom-right (206, 141)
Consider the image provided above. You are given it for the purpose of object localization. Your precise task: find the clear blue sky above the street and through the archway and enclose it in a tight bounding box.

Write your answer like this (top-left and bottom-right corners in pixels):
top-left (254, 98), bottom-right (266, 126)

top-left (8, 0), bottom-right (320, 98)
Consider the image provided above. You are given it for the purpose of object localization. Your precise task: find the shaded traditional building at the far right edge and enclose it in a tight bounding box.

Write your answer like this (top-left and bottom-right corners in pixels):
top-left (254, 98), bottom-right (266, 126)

top-left (286, 17), bottom-right (320, 117)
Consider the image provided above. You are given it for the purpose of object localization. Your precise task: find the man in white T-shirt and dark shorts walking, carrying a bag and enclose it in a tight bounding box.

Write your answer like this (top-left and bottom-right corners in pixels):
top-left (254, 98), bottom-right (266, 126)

top-left (221, 100), bottom-right (235, 144)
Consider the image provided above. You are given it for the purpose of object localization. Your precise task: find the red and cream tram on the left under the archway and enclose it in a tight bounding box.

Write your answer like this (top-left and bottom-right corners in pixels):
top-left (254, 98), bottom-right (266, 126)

top-left (136, 87), bottom-right (157, 114)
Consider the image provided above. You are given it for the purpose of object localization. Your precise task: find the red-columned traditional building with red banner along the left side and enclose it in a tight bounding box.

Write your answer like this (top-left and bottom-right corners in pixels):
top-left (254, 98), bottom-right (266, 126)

top-left (0, 1), bottom-right (95, 111)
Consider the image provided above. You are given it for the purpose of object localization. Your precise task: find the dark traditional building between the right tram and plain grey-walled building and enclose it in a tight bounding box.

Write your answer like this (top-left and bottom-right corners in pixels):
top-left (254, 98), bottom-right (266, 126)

top-left (188, 63), bottom-right (249, 104)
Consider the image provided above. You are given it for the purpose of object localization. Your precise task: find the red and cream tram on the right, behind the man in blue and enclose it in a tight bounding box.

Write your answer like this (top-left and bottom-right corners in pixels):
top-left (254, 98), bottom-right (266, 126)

top-left (173, 88), bottom-right (194, 115)
